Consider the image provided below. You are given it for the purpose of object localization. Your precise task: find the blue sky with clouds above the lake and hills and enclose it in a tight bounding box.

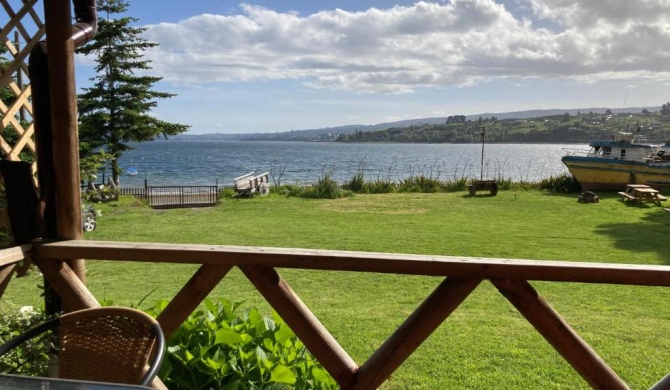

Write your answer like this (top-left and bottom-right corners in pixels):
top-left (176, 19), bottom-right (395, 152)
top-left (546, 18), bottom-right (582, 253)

top-left (77, 0), bottom-right (670, 134)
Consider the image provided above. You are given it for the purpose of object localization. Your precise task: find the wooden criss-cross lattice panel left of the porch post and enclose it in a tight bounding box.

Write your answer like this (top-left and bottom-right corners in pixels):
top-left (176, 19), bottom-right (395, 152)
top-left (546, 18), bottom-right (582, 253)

top-left (0, 0), bottom-right (45, 165)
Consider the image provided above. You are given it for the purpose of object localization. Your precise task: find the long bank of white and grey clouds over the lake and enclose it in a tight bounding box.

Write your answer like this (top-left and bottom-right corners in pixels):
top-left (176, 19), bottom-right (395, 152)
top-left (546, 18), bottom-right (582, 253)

top-left (146, 0), bottom-right (670, 94)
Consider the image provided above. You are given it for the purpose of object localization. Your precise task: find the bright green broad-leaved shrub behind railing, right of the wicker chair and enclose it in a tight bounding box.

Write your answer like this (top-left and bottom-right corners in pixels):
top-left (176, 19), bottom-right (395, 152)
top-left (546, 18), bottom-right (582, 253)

top-left (151, 300), bottom-right (337, 390)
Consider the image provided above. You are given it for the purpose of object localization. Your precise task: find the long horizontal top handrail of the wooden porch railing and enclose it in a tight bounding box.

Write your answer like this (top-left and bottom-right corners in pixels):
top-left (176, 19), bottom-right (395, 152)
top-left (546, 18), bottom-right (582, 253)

top-left (34, 240), bottom-right (670, 286)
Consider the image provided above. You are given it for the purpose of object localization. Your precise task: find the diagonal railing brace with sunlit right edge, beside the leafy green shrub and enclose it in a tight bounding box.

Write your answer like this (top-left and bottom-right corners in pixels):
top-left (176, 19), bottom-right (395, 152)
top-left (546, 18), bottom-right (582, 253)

top-left (240, 266), bottom-right (358, 387)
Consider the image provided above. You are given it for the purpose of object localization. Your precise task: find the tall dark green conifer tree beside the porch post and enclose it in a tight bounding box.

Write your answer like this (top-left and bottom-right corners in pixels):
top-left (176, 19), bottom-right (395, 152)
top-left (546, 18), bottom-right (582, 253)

top-left (77, 0), bottom-right (189, 185)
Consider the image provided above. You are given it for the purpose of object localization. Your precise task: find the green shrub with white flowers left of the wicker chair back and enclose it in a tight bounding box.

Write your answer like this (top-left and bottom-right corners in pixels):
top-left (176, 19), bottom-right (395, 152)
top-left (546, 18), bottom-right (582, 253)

top-left (0, 305), bottom-right (51, 376)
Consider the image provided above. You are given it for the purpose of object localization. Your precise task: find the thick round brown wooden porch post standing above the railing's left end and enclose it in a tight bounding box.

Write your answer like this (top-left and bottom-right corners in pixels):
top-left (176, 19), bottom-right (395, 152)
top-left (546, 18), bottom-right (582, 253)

top-left (44, 0), bottom-right (86, 283)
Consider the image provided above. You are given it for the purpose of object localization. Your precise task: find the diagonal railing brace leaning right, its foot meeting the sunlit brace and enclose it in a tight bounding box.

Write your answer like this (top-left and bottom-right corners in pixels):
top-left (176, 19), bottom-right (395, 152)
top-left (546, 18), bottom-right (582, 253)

top-left (356, 278), bottom-right (481, 389)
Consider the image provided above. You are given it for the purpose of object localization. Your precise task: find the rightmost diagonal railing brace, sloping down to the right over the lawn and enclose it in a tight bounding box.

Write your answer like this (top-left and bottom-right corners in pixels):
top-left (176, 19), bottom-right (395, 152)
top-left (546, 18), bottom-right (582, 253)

top-left (491, 280), bottom-right (628, 390)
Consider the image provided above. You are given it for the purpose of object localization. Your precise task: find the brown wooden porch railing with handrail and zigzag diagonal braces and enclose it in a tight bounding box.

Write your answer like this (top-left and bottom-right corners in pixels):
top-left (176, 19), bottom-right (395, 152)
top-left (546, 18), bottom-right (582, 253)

top-left (0, 240), bottom-right (670, 390)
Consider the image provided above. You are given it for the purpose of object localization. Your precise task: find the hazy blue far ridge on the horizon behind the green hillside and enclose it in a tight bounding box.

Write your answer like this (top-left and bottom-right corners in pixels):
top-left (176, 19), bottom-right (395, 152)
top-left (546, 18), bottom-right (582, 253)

top-left (171, 106), bottom-right (661, 141)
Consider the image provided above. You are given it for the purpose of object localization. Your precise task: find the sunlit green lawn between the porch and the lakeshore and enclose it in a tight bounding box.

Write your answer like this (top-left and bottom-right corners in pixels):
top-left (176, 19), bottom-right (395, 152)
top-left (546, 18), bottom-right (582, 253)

top-left (6, 191), bottom-right (670, 389)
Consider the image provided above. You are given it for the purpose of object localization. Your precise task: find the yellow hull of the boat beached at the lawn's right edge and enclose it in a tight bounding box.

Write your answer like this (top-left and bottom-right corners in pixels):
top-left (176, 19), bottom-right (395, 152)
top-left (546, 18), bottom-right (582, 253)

top-left (562, 156), bottom-right (670, 191)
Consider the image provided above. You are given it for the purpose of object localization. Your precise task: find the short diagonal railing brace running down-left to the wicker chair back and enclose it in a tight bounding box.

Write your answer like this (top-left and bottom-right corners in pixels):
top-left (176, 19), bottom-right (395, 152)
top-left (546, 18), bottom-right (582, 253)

top-left (156, 264), bottom-right (233, 339)
